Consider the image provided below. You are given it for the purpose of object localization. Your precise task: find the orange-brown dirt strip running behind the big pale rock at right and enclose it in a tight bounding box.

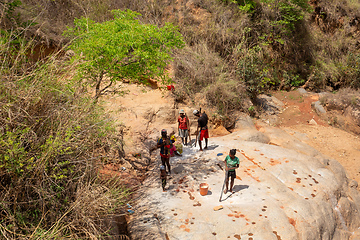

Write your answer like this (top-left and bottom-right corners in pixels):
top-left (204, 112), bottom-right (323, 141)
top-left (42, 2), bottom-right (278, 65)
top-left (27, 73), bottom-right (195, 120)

top-left (274, 91), bottom-right (360, 182)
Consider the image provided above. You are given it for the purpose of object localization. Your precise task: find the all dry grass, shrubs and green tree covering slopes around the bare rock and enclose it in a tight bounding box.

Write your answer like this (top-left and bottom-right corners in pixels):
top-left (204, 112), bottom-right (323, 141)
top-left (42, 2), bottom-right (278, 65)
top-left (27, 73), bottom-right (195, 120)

top-left (0, 0), bottom-right (360, 239)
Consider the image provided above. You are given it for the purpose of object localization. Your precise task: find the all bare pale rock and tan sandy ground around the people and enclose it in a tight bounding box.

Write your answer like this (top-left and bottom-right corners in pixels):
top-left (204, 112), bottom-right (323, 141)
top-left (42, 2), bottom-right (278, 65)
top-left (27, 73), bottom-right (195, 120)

top-left (100, 84), bottom-right (360, 240)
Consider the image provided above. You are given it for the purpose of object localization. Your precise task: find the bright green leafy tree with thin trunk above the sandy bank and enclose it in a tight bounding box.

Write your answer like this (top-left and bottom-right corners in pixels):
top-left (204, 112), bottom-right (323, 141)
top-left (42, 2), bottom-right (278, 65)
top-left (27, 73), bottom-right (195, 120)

top-left (65, 10), bottom-right (184, 99)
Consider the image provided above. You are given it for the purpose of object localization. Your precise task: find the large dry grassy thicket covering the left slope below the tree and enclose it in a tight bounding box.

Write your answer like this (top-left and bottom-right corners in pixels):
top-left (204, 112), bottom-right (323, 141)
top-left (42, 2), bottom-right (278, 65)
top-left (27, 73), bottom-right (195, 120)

top-left (0, 32), bottom-right (127, 239)
